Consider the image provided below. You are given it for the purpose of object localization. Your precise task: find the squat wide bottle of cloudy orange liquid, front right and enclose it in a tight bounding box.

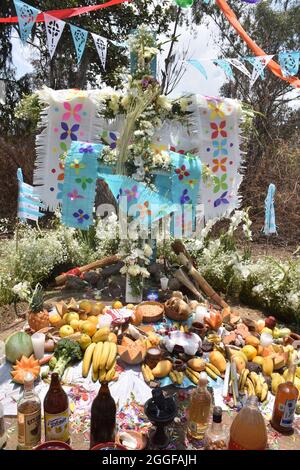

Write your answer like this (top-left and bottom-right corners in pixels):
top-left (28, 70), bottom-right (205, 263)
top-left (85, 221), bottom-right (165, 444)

top-left (228, 396), bottom-right (268, 450)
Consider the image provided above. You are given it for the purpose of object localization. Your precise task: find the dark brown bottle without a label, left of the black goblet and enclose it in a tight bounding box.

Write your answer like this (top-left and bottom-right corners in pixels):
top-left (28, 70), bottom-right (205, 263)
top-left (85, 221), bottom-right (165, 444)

top-left (90, 382), bottom-right (117, 448)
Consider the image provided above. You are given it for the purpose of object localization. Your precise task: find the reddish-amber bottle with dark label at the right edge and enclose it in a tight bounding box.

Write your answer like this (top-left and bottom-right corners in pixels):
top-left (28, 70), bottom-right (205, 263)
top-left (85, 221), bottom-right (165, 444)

top-left (271, 362), bottom-right (299, 434)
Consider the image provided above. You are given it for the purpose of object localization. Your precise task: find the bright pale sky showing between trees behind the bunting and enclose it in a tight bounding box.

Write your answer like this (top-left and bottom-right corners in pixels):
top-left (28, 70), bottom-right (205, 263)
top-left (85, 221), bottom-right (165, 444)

top-left (12, 13), bottom-right (225, 96)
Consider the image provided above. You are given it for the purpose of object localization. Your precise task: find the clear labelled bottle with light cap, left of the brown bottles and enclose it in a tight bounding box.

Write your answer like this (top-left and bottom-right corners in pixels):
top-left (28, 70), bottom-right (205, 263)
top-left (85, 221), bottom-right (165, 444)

top-left (17, 372), bottom-right (41, 450)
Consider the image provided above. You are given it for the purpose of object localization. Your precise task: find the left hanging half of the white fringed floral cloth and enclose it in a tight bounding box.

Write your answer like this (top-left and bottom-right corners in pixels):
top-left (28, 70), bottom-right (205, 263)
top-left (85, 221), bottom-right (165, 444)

top-left (33, 88), bottom-right (101, 210)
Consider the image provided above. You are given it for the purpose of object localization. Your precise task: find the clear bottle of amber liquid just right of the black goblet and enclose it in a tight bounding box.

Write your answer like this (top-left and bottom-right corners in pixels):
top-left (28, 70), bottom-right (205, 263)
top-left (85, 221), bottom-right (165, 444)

top-left (187, 372), bottom-right (212, 439)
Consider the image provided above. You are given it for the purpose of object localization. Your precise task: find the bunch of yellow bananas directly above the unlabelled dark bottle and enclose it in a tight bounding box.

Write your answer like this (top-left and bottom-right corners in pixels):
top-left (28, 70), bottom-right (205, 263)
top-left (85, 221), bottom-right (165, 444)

top-left (82, 341), bottom-right (117, 382)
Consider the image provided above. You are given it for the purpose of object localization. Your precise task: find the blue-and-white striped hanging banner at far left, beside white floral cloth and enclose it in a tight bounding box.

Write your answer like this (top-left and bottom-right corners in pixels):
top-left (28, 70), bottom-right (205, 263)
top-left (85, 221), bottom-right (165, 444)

top-left (17, 168), bottom-right (44, 221)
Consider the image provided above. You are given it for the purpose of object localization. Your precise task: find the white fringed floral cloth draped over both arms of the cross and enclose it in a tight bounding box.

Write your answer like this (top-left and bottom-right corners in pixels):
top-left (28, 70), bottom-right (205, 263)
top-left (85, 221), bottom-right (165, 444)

top-left (34, 88), bottom-right (242, 221)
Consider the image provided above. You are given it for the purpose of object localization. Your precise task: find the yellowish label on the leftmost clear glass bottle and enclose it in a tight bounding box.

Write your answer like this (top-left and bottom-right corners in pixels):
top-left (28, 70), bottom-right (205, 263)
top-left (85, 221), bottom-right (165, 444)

top-left (18, 409), bottom-right (41, 447)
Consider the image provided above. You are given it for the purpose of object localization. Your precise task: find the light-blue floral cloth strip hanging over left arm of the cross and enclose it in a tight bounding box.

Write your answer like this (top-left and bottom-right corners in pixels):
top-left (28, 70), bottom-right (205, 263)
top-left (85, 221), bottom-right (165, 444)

top-left (62, 142), bottom-right (103, 230)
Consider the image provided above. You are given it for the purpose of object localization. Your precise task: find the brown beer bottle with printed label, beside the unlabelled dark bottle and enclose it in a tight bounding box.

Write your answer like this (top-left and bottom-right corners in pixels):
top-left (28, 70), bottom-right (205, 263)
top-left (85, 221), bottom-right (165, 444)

top-left (44, 373), bottom-right (70, 442)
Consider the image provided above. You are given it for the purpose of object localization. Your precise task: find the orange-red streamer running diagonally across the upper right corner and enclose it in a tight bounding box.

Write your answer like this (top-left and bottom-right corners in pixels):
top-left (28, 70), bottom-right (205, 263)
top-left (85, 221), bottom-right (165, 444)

top-left (216, 0), bottom-right (300, 88)
